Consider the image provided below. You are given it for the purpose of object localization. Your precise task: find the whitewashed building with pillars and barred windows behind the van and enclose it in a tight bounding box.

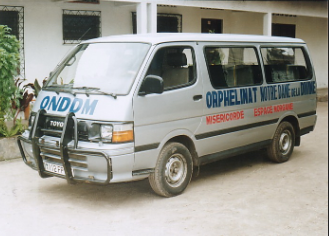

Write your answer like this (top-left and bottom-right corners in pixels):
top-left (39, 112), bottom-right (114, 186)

top-left (0, 0), bottom-right (328, 88)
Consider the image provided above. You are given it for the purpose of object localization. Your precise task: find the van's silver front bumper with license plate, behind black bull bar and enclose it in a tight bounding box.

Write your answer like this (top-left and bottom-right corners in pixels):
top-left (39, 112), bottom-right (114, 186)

top-left (17, 136), bottom-right (135, 184)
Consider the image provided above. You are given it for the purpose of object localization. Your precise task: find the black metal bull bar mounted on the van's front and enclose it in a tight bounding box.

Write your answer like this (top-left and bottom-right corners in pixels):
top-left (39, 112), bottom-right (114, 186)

top-left (17, 109), bottom-right (112, 184)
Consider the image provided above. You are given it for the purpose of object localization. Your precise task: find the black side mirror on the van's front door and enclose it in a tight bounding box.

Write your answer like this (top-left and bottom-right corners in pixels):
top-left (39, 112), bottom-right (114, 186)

top-left (138, 75), bottom-right (163, 96)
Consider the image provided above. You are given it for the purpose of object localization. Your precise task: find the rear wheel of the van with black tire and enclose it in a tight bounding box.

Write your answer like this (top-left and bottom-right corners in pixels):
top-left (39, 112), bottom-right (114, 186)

top-left (267, 121), bottom-right (295, 163)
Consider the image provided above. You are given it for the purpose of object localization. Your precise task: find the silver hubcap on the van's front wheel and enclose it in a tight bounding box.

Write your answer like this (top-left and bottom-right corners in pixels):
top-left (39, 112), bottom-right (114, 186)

top-left (165, 154), bottom-right (187, 187)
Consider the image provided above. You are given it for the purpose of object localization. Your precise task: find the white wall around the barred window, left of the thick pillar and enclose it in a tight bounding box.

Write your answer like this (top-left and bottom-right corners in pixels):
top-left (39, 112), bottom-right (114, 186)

top-left (25, 2), bottom-right (135, 81)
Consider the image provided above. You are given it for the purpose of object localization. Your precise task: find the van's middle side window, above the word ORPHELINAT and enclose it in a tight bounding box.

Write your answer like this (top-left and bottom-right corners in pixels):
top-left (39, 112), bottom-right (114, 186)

top-left (205, 47), bottom-right (263, 88)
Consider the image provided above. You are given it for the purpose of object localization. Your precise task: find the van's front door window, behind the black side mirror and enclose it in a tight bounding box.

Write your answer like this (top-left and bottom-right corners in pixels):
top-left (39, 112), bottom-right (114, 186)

top-left (146, 47), bottom-right (195, 90)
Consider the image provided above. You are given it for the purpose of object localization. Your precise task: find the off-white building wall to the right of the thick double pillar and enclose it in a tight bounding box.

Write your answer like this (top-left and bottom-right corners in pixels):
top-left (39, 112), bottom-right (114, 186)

top-left (158, 6), bottom-right (328, 88)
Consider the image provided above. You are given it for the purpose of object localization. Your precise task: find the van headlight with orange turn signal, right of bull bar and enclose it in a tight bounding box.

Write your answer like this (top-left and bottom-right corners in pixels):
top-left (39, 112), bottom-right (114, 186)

top-left (78, 121), bottom-right (134, 143)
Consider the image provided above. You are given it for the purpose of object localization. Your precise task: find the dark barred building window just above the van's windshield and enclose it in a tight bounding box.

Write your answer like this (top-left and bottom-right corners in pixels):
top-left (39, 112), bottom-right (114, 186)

top-left (63, 10), bottom-right (101, 44)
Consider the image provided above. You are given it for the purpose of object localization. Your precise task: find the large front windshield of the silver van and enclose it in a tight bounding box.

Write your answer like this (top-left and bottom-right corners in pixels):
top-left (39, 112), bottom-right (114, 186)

top-left (45, 43), bottom-right (150, 95)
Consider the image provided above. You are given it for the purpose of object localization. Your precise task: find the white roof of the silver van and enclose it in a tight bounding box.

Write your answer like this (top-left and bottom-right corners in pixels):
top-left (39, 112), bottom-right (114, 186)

top-left (84, 33), bottom-right (305, 44)
